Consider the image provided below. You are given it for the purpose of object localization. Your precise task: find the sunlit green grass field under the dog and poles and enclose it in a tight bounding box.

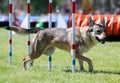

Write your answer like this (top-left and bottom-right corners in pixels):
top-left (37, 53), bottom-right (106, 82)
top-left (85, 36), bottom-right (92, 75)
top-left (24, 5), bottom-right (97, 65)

top-left (0, 29), bottom-right (120, 83)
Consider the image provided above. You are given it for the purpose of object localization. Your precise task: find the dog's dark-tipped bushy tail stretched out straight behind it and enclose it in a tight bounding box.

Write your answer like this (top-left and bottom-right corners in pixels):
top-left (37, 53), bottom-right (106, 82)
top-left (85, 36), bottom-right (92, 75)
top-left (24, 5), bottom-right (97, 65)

top-left (6, 26), bottom-right (43, 35)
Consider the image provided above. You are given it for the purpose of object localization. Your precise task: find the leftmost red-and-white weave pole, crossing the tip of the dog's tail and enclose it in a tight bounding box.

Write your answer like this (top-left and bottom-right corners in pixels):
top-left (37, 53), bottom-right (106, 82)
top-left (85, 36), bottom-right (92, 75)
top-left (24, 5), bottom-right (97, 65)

top-left (9, 0), bottom-right (13, 65)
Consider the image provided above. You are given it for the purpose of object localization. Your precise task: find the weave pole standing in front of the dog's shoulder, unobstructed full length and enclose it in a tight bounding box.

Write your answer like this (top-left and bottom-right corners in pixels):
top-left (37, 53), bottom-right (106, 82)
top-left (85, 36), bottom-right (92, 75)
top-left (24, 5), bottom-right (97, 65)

top-left (71, 0), bottom-right (76, 73)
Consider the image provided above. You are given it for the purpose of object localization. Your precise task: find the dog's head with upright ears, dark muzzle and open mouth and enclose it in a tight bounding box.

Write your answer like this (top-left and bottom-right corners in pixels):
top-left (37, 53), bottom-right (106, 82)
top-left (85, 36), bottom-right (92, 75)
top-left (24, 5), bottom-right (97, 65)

top-left (88, 18), bottom-right (106, 44)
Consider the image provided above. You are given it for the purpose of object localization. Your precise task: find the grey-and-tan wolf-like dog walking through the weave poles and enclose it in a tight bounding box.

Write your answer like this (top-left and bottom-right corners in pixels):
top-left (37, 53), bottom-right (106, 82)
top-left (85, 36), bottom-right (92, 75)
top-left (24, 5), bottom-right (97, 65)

top-left (6, 18), bottom-right (106, 72)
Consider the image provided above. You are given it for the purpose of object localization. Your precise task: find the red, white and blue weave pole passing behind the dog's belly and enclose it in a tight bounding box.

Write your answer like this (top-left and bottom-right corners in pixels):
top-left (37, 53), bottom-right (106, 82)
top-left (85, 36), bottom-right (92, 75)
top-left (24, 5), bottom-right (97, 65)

top-left (48, 0), bottom-right (53, 71)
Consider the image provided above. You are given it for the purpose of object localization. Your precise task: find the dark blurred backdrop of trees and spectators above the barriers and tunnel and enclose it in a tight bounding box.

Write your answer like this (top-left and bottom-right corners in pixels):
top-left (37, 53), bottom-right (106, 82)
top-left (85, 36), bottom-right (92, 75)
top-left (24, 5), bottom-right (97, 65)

top-left (0, 0), bottom-right (120, 15)
